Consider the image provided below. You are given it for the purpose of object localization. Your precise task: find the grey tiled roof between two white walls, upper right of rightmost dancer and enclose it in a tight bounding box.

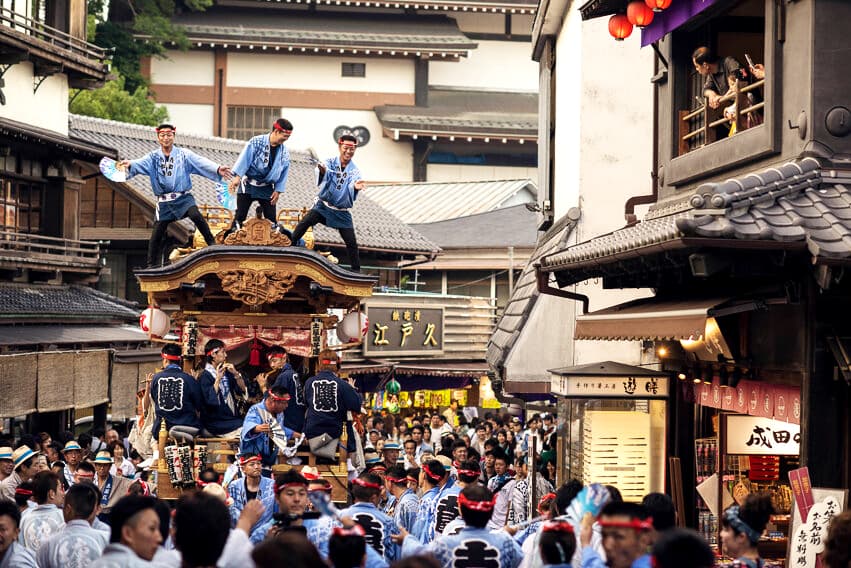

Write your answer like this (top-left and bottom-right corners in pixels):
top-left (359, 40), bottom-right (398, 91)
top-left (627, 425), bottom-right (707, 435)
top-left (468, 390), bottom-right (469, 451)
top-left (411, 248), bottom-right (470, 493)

top-left (375, 87), bottom-right (538, 139)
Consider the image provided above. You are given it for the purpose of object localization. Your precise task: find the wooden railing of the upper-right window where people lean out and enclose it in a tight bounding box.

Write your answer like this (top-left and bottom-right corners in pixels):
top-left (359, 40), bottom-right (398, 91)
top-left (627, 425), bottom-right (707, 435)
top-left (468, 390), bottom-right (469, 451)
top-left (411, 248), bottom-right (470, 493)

top-left (678, 79), bottom-right (765, 156)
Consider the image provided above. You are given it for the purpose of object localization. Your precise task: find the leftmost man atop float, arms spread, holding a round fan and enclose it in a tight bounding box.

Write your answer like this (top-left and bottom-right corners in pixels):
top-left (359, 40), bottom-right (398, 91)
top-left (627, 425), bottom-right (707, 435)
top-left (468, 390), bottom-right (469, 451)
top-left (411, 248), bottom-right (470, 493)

top-left (115, 124), bottom-right (231, 268)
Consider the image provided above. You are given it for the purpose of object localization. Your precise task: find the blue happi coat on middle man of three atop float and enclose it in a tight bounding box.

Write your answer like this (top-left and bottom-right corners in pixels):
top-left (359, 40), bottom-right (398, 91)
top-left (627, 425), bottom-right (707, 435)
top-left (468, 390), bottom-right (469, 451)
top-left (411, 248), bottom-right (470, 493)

top-left (231, 134), bottom-right (290, 199)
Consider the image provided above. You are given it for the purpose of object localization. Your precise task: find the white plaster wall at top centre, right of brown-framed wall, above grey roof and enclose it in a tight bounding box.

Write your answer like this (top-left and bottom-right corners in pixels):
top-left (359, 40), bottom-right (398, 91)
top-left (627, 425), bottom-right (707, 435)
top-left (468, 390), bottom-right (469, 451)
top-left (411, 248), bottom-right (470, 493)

top-left (428, 40), bottom-right (538, 92)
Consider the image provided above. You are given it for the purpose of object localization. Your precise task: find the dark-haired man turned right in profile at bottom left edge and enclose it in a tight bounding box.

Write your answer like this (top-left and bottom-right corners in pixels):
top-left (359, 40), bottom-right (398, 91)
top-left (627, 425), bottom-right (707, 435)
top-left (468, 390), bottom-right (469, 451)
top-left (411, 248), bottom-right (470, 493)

top-left (92, 494), bottom-right (163, 568)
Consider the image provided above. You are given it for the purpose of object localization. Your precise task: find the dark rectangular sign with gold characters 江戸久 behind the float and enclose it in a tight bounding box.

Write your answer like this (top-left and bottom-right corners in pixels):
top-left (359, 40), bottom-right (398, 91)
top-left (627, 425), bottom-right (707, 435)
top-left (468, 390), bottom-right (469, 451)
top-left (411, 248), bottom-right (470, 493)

top-left (364, 304), bottom-right (443, 355)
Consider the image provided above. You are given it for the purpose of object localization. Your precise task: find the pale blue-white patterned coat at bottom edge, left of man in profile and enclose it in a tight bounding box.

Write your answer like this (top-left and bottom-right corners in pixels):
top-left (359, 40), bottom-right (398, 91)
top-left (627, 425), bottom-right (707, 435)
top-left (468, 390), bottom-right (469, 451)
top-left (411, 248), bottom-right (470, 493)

top-left (36, 519), bottom-right (109, 568)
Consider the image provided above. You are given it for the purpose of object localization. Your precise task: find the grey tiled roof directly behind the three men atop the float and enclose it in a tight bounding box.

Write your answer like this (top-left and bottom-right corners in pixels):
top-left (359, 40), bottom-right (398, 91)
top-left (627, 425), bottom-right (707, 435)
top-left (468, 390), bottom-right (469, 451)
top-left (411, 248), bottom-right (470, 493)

top-left (70, 115), bottom-right (439, 253)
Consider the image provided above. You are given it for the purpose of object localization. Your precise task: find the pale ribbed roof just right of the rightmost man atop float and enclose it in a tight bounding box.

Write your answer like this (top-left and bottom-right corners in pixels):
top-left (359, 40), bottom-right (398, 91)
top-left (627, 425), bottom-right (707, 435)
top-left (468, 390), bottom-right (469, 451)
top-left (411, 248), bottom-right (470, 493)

top-left (369, 179), bottom-right (538, 223)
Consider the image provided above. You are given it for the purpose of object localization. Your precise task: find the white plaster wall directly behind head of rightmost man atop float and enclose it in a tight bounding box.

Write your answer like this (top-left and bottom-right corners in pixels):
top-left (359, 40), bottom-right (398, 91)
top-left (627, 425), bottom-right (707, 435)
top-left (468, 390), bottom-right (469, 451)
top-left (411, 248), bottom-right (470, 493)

top-left (281, 108), bottom-right (413, 181)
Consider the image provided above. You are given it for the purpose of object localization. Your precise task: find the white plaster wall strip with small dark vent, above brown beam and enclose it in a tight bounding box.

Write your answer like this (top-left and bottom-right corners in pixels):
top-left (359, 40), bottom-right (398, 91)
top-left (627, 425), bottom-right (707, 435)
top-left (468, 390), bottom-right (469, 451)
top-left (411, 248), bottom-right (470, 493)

top-left (227, 52), bottom-right (414, 93)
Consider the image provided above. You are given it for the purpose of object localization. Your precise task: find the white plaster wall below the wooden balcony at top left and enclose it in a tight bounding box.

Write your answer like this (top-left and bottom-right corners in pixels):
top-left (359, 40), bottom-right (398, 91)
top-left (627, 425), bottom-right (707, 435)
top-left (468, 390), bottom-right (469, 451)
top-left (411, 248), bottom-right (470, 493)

top-left (0, 62), bottom-right (68, 136)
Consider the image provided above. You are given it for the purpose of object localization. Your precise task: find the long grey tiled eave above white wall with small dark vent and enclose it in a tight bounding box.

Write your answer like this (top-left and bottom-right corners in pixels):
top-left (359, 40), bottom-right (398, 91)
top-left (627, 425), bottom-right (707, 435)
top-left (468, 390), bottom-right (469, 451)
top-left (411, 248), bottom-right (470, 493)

top-left (172, 7), bottom-right (476, 56)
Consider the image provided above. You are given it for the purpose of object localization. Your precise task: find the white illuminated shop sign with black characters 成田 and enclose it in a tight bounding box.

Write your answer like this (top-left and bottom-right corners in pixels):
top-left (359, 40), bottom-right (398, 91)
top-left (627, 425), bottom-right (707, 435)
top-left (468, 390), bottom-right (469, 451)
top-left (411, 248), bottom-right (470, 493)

top-left (725, 415), bottom-right (801, 456)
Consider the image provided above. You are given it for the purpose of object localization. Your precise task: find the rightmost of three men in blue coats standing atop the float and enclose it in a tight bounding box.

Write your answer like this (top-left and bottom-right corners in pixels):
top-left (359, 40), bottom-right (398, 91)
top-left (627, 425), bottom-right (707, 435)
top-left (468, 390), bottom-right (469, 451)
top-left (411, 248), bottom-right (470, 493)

top-left (292, 134), bottom-right (366, 272)
